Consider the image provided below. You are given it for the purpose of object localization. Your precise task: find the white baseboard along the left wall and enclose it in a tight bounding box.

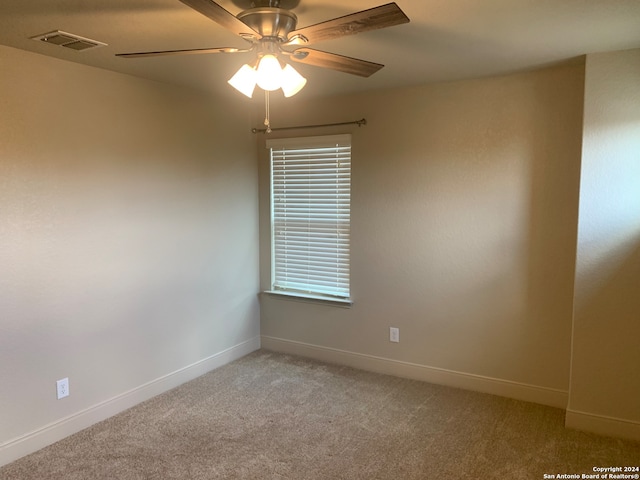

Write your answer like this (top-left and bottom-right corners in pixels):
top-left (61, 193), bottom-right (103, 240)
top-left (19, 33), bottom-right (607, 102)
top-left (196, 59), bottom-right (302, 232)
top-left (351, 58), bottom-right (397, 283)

top-left (0, 336), bottom-right (260, 467)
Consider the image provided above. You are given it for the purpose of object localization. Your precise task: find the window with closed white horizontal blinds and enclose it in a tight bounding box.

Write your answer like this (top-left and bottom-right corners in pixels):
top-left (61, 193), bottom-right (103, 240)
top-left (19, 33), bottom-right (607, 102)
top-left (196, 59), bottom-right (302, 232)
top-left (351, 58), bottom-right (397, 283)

top-left (267, 135), bottom-right (351, 301)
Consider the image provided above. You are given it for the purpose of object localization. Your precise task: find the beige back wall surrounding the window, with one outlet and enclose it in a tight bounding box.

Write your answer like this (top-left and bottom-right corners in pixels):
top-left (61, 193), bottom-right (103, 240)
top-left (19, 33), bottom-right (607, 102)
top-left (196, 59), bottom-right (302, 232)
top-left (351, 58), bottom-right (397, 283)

top-left (259, 63), bottom-right (584, 405)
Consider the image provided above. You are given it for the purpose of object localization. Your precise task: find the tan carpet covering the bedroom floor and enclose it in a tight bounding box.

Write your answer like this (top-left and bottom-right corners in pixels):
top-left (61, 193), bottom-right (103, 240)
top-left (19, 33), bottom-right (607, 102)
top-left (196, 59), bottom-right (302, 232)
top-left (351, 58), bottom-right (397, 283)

top-left (0, 350), bottom-right (640, 480)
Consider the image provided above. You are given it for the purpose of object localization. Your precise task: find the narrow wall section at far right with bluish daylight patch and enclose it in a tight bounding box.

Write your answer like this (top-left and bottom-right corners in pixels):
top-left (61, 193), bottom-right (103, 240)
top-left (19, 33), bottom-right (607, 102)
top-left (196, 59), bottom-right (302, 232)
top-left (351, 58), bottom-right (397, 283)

top-left (567, 50), bottom-right (640, 439)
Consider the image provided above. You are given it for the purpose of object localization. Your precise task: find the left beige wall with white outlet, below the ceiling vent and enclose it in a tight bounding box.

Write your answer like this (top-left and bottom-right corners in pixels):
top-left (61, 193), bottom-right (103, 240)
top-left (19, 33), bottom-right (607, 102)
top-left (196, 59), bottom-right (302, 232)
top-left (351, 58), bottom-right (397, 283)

top-left (0, 47), bottom-right (259, 463)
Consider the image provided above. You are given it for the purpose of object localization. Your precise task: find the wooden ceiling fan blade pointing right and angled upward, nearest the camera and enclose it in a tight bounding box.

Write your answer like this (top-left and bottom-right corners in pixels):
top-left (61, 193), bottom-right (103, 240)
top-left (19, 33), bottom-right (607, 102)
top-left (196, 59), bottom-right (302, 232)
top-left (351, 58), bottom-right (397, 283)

top-left (286, 0), bottom-right (409, 44)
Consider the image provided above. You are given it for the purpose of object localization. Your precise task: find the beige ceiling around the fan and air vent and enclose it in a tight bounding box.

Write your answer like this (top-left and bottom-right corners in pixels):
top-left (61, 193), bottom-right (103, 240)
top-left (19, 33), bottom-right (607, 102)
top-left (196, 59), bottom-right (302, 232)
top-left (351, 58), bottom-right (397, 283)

top-left (0, 0), bottom-right (640, 98)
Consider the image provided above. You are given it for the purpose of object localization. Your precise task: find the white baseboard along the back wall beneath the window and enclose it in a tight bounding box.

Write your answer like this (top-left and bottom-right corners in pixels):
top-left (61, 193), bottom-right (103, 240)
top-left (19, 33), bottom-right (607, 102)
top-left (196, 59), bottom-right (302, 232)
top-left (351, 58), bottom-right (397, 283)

top-left (261, 335), bottom-right (568, 409)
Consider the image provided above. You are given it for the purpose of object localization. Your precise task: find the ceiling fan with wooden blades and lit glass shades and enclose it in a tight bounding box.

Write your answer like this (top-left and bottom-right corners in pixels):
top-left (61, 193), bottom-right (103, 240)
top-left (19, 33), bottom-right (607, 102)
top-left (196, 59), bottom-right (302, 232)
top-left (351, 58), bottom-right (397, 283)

top-left (116, 0), bottom-right (409, 97)
